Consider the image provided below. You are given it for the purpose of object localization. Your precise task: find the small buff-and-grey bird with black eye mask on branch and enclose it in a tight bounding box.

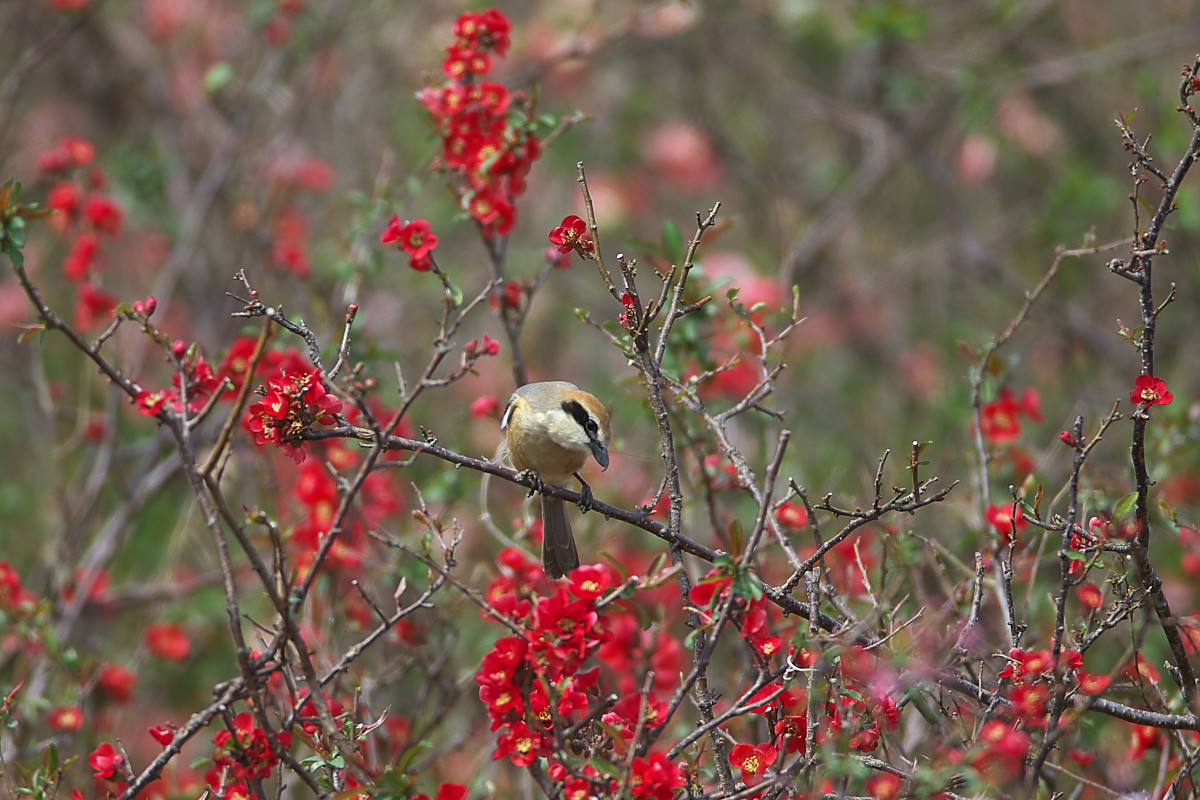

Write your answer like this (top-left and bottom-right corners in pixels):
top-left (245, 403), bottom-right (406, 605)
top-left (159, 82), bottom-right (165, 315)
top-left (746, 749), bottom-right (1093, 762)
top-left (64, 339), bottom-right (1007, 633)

top-left (500, 380), bottom-right (610, 579)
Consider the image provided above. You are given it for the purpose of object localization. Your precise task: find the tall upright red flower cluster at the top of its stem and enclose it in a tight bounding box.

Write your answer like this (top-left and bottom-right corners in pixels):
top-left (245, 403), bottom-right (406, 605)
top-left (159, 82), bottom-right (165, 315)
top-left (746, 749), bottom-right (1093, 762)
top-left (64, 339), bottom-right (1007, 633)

top-left (418, 8), bottom-right (541, 236)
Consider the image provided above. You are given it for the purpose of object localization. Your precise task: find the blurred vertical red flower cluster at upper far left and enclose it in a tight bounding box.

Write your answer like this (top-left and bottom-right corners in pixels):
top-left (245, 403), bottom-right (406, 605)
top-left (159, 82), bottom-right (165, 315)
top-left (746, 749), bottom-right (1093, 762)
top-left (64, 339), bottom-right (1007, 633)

top-left (38, 137), bottom-right (125, 330)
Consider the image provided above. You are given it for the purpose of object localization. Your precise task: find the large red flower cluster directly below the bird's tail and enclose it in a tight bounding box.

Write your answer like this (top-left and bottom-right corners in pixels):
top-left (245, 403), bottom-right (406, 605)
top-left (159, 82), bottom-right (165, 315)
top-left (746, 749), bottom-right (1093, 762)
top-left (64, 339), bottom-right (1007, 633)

top-left (475, 549), bottom-right (684, 798)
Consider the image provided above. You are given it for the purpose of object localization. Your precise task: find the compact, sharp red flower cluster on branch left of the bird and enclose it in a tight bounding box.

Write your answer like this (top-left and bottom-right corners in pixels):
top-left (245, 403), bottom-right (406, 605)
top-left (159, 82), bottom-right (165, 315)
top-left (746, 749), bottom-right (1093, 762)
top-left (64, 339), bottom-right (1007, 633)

top-left (246, 368), bottom-right (342, 464)
